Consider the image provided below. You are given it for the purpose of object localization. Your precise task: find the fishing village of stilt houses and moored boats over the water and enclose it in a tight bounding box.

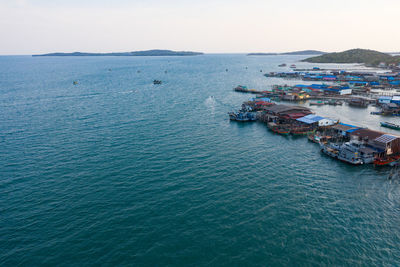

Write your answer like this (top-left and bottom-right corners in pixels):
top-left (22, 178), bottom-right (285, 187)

top-left (228, 64), bottom-right (400, 166)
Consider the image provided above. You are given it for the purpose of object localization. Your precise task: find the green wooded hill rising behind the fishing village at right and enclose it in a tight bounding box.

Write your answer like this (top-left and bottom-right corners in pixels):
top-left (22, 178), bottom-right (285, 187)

top-left (302, 48), bottom-right (400, 66)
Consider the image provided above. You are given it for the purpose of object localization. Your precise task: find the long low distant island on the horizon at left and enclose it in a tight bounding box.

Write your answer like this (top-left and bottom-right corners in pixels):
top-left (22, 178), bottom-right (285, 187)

top-left (32, 50), bottom-right (203, 57)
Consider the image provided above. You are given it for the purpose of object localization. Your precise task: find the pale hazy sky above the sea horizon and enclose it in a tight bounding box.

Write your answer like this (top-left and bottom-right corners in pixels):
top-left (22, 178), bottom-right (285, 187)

top-left (0, 0), bottom-right (400, 55)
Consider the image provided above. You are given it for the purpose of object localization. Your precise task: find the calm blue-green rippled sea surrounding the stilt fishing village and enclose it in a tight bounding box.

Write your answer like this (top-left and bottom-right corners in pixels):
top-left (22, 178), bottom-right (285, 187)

top-left (0, 55), bottom-right (400, 266)
